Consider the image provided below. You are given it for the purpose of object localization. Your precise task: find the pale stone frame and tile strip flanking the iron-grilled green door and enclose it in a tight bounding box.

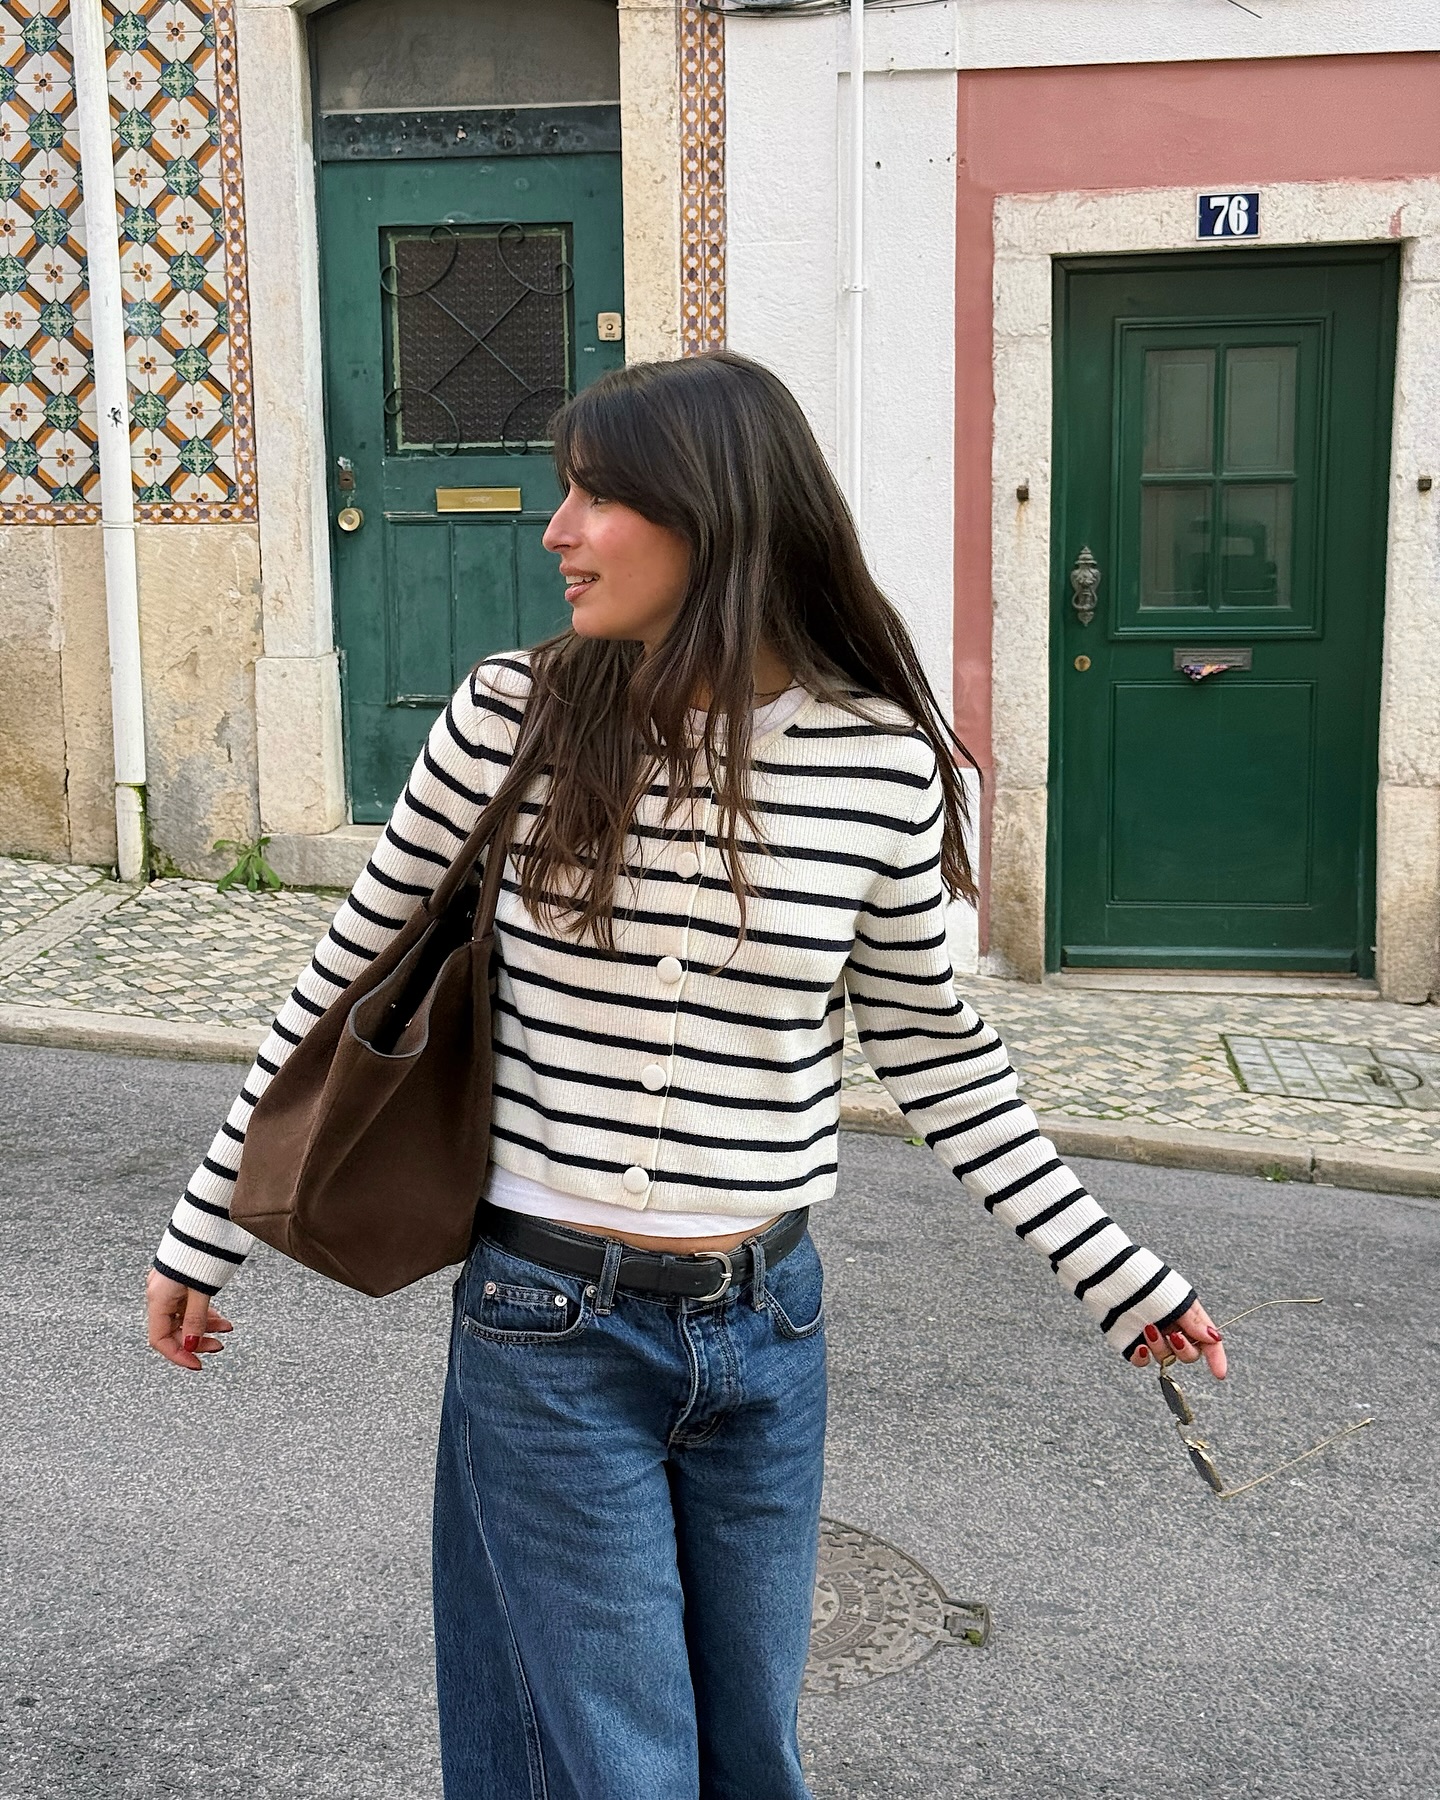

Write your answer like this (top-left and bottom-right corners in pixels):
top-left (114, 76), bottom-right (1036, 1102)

top-left (236, 0), bottom-right (702, 871)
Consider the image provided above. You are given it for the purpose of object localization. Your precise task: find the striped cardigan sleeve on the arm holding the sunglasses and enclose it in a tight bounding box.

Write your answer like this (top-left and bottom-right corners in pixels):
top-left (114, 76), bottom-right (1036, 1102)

top-left (846, 741), bottom-right (1195, 1354)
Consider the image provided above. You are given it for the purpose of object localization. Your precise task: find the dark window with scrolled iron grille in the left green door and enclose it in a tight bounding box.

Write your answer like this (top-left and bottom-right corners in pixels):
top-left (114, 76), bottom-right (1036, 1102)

top-left (380, 225), bottom-right (574, 454)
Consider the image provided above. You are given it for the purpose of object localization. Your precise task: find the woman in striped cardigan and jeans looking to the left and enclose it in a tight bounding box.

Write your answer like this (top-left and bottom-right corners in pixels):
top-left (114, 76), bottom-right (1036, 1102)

top-left (149, 355), bottom-right (1224, 1800)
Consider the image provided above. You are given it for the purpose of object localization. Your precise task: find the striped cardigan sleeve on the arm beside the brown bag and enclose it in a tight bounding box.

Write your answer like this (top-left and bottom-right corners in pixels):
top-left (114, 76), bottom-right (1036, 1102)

top-left (155, 657), bottom-right (529, 1294)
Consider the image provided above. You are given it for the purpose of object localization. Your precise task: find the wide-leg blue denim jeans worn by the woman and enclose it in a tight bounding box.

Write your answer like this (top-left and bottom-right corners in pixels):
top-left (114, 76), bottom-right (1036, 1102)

top-left (434, 1237), bottom-right (824, 1800)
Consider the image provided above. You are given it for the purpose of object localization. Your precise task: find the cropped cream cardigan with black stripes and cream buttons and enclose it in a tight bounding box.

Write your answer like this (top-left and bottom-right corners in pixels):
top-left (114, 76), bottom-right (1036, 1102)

top-left (155, 653), bottom-right (1193, 1350)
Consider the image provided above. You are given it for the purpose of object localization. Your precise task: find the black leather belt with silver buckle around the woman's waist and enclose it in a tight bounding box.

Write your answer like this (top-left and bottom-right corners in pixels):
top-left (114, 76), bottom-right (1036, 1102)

top-left (475, 1201), bottom-right (810, 1300)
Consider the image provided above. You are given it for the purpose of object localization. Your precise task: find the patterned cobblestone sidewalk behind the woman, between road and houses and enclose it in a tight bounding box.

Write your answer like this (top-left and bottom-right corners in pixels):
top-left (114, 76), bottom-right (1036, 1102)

top-left (0, 859), bottom-right (1440, 1156)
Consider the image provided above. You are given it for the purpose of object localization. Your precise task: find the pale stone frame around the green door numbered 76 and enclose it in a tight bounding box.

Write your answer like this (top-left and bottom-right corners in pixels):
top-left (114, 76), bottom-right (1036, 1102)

top-left (990, 180), bottom-right (1440, 1003)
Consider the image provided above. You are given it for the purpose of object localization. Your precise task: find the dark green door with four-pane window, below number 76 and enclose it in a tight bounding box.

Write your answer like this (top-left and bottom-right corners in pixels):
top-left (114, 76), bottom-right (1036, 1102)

top-left (1049, 248), bottom-right (1397, 974)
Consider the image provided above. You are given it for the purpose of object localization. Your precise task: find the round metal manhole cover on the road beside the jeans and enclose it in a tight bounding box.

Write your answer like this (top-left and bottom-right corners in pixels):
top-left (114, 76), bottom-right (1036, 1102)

top-left (805, 1519), bottom-right (990, 1694)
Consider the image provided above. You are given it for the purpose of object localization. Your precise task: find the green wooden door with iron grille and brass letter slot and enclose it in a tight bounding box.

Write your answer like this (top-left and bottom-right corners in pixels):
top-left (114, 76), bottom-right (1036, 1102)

top-left (320, 153), bottom-right (623, 821)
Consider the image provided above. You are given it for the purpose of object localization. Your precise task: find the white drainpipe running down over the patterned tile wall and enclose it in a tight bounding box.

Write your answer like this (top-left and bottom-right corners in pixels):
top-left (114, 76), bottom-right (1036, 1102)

top-left (70, 0), bottom-right (149, 882)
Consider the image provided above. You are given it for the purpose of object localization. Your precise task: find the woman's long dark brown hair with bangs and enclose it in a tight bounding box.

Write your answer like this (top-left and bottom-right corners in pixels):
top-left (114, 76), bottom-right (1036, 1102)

top-left (504, 351), bottom-right (976, 945)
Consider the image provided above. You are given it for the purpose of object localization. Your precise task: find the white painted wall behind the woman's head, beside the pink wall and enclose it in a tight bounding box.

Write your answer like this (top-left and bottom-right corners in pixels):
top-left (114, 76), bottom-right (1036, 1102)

top-left (725, 7), bottom-right (976, 968)
